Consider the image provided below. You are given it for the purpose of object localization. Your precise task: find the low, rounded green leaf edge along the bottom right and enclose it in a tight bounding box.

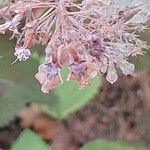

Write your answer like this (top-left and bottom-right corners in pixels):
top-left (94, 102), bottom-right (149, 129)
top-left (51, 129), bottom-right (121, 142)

top-left (80, 140), bottom-right (145, 150)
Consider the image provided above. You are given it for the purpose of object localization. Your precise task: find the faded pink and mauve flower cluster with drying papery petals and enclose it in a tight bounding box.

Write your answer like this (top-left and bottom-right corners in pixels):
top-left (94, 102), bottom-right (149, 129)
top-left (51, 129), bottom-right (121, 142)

top-left (0, 0), bottom-right (150, 93)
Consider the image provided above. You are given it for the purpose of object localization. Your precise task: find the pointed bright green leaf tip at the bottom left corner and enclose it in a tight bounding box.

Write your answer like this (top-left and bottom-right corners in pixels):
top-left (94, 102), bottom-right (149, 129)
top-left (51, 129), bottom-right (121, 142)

top-left (11, 129), bottom-right (50, 150)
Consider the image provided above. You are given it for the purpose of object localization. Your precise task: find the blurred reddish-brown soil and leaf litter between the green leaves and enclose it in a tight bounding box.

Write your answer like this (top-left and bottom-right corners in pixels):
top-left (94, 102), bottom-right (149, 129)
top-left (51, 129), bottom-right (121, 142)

top-left (0, 72), bottom-right (150, 150)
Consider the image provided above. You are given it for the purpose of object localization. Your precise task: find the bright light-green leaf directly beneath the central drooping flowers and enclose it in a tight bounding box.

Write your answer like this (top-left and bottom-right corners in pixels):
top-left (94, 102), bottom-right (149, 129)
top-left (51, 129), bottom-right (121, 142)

top-left (44, 70), bottom-right (100, 119)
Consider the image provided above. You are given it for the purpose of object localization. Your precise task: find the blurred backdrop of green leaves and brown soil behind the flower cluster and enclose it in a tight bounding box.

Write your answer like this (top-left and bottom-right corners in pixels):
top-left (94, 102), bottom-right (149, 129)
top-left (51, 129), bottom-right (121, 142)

top-left (0, 30), bottom-right (150, 150)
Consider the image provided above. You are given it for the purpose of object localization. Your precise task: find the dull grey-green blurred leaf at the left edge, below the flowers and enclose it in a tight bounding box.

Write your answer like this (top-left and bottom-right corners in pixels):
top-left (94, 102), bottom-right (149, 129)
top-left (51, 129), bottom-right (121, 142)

top-left (0, 74), bottom-right (57, 126)
